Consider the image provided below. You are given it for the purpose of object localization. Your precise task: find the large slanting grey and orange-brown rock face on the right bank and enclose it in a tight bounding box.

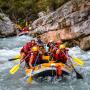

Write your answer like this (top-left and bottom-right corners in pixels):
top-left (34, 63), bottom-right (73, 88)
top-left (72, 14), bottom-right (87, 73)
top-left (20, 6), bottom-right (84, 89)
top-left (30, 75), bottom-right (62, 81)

top-left (30, 0), bottom-right (90, 50)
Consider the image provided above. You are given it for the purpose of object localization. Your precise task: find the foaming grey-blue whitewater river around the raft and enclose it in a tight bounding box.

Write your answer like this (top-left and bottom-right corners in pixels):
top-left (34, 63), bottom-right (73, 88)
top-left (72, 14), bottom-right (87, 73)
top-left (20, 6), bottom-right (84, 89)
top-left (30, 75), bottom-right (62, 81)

top-left (0, 36), bottom-right (90, 90)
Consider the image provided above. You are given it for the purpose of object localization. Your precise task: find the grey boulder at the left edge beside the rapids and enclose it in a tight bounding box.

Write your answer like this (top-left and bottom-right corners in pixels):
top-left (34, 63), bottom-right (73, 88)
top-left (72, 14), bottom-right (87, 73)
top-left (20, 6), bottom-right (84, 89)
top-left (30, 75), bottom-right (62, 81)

top-left (0, 13), bottom-right (16, 37)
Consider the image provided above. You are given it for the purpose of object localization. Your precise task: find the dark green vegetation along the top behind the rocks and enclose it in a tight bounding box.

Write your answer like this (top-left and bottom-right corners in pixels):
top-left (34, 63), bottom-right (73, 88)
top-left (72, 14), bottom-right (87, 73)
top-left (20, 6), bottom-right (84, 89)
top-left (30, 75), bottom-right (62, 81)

top-left (0, 0), bottom-right (69, 22)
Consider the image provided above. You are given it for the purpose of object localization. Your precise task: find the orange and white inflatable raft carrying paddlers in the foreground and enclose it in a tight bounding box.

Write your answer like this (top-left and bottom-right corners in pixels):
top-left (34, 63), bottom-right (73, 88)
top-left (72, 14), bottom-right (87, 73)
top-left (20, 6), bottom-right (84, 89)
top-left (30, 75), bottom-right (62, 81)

top-left (25, 61), bottom-right (73, 78)
